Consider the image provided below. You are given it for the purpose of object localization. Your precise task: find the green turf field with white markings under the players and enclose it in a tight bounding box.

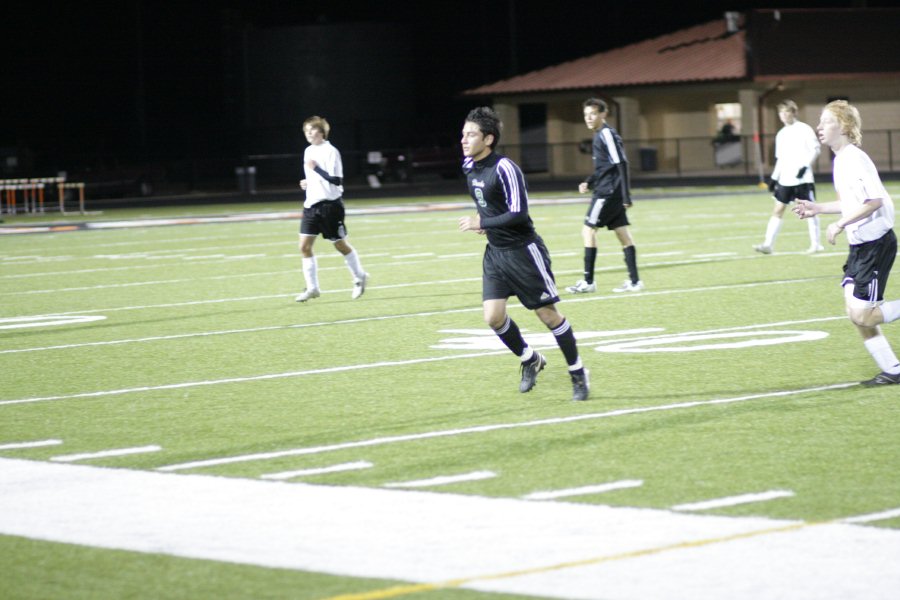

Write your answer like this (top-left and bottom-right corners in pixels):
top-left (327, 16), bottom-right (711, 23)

top-left (0, 184), bottom-right (900, 600)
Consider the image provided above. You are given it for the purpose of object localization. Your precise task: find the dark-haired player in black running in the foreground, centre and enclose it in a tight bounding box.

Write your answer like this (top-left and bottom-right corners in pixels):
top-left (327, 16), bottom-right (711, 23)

top-left (459, 106), bottom-right (589, 400)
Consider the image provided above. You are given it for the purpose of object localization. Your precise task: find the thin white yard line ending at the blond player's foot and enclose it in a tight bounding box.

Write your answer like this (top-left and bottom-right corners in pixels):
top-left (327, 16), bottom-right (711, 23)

top-left (156, 382), bottom-right (859, 472)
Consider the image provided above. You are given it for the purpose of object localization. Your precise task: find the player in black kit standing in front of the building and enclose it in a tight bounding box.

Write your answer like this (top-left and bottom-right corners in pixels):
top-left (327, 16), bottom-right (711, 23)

top-left (567, 98), bottom-right (644, 294)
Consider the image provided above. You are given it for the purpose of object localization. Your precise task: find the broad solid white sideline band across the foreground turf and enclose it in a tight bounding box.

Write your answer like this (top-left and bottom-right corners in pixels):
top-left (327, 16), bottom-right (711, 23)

top-left (0, 459), bottom-right (900, 600)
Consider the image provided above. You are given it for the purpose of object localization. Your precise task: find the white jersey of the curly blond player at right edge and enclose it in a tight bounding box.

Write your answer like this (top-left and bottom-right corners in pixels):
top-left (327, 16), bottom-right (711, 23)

top-left (834, 144), bottom-right (894, 245)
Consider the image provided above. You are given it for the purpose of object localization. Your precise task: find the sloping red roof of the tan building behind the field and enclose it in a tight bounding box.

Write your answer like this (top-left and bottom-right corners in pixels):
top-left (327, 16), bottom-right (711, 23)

top-left (463, 19), bottom-right (747, 96)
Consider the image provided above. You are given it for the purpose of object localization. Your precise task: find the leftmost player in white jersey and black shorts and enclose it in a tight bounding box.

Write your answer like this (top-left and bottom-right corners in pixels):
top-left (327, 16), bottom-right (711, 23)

top-left (297, 116), bottom-right (369, 302)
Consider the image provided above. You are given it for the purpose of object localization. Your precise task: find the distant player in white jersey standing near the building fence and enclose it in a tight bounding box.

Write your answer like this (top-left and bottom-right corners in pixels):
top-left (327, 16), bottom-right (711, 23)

top-left (753, 100), bottom-right (824, 254)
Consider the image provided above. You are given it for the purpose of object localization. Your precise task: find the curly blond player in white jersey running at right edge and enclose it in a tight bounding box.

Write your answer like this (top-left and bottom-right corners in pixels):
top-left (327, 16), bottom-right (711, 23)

top-left (794, 100), bottom-right (900, 386)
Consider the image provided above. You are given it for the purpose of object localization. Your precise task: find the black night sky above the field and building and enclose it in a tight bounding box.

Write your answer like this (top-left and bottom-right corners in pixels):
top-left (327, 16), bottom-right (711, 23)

top-left (0, 0), bottom-right (889, 171)
